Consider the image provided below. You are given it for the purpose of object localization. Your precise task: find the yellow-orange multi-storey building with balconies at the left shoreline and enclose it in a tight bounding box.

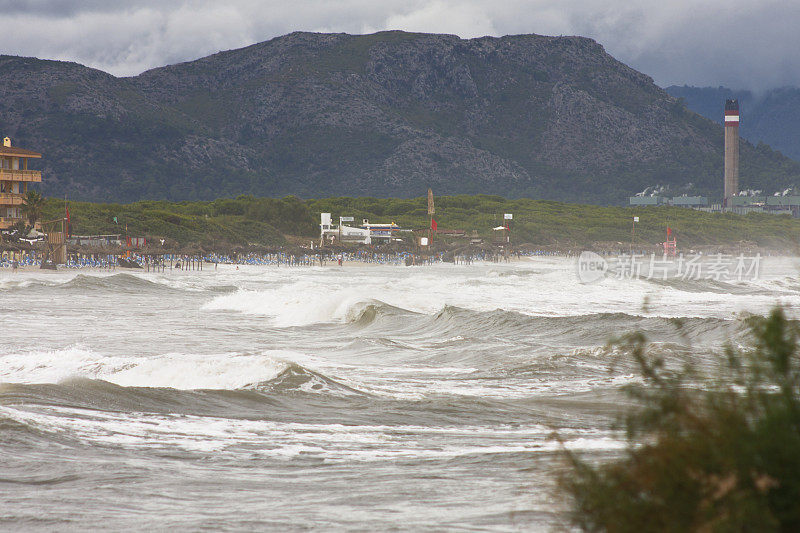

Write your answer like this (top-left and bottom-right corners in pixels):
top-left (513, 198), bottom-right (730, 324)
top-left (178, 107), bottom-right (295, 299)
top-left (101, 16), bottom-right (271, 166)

top-left (0, 137), bottom-right (42, 230)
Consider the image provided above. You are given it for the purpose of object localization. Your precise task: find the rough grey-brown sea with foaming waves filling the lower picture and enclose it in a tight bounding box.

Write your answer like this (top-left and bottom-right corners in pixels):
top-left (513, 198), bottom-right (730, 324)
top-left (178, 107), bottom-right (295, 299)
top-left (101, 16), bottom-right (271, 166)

top-left (0, 258), bottom-right (800, 531)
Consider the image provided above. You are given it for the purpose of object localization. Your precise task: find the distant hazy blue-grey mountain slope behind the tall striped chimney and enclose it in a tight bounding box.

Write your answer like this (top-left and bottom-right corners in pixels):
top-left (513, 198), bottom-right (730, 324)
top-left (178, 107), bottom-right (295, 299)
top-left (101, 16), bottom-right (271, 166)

top-left (666, 85), bottom-right (800, 160)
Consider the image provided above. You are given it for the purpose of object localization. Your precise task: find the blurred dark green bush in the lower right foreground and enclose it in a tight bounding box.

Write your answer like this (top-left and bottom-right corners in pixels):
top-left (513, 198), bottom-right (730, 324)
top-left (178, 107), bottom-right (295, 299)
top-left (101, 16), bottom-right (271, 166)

top-left (563, 309), bottom-right (800, 531)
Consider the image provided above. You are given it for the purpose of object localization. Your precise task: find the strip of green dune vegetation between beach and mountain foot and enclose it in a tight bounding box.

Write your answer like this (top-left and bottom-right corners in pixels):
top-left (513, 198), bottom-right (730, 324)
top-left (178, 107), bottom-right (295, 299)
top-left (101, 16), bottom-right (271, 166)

top-left (42, 195), bottom-right (800, 253)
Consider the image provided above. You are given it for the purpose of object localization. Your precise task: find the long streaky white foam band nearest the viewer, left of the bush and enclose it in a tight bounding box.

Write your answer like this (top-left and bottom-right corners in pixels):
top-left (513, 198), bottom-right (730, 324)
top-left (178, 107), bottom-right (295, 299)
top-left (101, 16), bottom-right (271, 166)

top-left (0, 406), bottom-right (625, 461)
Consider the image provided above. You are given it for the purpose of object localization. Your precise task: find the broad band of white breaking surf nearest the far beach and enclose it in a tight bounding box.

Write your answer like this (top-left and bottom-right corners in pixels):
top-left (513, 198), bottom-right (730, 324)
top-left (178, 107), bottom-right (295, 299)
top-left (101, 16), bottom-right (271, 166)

top-left (198, 258), bottom-right (800, 327)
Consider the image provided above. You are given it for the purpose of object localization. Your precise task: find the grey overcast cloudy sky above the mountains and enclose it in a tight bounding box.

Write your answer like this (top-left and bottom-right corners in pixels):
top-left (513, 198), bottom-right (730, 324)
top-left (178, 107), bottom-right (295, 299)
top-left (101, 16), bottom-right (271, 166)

top-left (0, 0), bottom-right (800, 90)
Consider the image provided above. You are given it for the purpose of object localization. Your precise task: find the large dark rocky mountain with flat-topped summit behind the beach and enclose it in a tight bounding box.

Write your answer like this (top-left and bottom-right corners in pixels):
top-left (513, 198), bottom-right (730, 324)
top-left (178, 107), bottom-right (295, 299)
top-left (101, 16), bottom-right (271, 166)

top-left (0, 32), bottom-right (800, 203)
